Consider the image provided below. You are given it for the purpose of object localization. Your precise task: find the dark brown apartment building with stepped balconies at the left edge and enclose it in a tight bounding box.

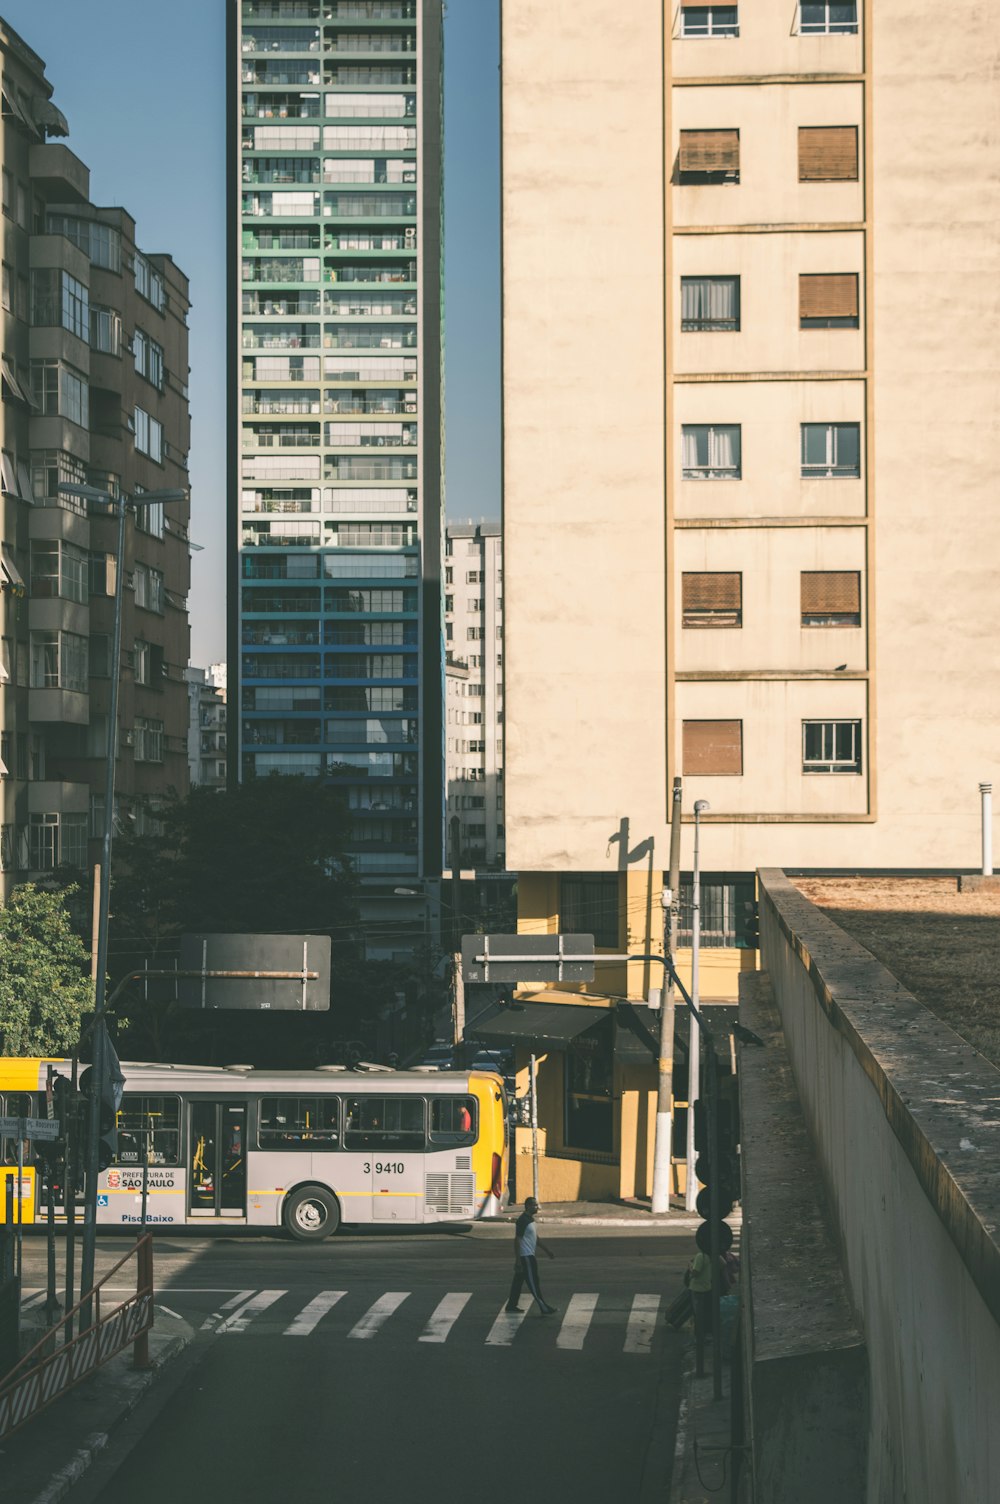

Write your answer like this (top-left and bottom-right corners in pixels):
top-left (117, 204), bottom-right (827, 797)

top-left (0, 23), bottom-right (189, 896)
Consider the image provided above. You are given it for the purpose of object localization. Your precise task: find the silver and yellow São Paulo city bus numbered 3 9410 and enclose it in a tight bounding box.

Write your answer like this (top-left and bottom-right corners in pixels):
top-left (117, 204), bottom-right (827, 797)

top-left (0, 1059), bottom-right (508, 1241)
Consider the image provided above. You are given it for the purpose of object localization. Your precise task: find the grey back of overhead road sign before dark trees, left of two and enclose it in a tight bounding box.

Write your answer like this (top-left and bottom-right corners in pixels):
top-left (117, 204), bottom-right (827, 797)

top-left (177, 934), bottom-right (331, 1012)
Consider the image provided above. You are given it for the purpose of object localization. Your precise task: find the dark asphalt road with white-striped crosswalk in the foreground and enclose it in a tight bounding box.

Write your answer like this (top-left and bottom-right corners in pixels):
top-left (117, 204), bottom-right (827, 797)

top-left (26, 1223), bottom-right (690, 1504)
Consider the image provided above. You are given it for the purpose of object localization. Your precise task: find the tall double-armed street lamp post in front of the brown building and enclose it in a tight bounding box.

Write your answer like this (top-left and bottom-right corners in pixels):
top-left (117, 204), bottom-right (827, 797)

top-left (59, 483), bottom-right (188, 1327)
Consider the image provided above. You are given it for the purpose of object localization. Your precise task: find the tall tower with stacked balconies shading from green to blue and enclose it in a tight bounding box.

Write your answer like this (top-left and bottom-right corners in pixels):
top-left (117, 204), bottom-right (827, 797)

top-left (229, 0), bottom-right (444, 938)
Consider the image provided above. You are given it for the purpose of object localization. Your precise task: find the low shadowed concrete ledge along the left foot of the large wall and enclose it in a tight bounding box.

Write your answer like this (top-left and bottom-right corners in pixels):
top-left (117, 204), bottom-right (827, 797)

top-left (740, 973), bottom-right (869, 1504)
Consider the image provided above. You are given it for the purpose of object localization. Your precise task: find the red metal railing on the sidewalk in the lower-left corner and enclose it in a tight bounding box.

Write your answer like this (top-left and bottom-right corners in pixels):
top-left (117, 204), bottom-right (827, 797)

top-left (0, 1233), bottom-right (153, 1441)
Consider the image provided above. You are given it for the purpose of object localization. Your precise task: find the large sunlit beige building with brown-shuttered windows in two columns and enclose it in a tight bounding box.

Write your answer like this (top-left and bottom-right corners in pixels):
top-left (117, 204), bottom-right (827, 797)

top-left (502, 0), bottom-right (1000, 1196)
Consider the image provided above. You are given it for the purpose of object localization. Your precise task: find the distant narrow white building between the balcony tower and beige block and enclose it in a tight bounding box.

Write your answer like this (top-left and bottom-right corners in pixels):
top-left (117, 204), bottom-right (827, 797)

top-left (445, 522), bottom-right (507, 872)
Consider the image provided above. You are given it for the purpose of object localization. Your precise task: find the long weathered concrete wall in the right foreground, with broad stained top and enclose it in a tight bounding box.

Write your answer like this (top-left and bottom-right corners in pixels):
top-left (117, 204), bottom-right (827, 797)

top-left (759, 869), bottom-right (1000, 1504)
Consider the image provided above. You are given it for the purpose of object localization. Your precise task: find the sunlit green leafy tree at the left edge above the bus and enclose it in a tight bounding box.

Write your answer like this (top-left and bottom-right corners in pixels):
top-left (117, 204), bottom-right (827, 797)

top-left (0, 883), bottom-right (93, 1056)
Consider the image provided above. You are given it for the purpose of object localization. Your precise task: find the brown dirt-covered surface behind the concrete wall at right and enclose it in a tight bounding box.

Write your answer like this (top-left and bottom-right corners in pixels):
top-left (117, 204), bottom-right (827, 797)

top-left (795, 877), bottom-right (1000, 1068)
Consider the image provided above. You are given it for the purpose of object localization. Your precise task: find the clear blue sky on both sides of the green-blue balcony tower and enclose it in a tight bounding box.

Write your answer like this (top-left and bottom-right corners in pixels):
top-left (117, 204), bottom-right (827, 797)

top-left (0, 0), bottom-right (499, 665)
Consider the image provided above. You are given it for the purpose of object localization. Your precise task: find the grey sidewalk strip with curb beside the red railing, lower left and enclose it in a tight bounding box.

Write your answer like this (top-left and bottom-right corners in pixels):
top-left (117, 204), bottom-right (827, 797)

top-left (0, 1305), bottom-right (194, 1504)
